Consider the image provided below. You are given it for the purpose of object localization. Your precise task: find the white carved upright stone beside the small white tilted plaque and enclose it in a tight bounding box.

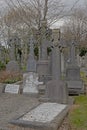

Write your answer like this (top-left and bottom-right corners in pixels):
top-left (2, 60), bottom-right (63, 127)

top-left (23, 72), bottom-right (43, 96)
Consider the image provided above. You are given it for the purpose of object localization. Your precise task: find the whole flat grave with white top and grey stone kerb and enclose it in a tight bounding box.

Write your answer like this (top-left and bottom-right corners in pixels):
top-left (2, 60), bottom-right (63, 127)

top-left (11, 102), bottom-right (68, 130)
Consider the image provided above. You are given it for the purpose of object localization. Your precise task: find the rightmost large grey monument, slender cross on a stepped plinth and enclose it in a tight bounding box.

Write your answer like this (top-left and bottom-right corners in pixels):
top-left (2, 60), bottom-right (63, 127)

top-left (66, 42), bottom-right (84, 94)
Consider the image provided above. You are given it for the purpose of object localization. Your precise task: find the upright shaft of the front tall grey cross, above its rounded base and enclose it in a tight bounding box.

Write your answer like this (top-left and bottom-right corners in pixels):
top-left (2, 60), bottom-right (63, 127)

top-left (52, 29), bottom-right (61, 79)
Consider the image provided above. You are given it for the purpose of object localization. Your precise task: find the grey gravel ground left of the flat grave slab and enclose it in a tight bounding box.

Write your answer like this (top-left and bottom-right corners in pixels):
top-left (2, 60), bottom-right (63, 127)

top-left (0, 94), bottom-right (39, 128)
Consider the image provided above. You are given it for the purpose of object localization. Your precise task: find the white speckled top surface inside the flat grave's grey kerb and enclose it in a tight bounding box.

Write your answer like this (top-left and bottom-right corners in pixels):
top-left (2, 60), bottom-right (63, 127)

top-left (19, 102), bottom-right (67, 123)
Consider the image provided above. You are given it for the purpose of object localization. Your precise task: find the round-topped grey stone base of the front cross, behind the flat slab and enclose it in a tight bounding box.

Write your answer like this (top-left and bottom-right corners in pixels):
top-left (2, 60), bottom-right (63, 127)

top-left (40, 80), bottom-right (68, 104)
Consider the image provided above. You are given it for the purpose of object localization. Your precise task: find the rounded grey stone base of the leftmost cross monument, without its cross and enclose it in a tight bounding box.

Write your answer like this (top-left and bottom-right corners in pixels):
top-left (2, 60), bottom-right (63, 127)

top-left (6, 61), bottom-right (20, 72)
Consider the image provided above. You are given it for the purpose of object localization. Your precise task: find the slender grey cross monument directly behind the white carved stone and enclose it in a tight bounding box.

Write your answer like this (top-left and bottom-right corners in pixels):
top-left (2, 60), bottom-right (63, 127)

top-left (27, 36), bottom-right (36, 72)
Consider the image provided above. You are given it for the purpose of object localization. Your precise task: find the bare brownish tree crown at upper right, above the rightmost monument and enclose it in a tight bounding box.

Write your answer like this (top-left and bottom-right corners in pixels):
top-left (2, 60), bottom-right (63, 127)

top-left (63, 8), bottom-right (87, 44)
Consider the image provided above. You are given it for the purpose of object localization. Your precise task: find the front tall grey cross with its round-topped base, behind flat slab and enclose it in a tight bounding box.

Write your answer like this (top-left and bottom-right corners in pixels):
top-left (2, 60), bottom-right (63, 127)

top-left (40, 29), bottom-right (68, 103)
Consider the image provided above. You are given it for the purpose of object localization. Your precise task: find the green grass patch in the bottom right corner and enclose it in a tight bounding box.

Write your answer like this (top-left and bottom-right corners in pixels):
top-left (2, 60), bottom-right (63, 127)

top-left (69, 95), bottom-right (87, 130)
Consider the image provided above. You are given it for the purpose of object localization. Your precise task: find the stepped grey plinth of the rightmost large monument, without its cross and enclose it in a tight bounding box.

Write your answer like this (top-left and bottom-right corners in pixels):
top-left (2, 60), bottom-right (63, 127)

top-left (66, 65), bottom-right (84, 94)
